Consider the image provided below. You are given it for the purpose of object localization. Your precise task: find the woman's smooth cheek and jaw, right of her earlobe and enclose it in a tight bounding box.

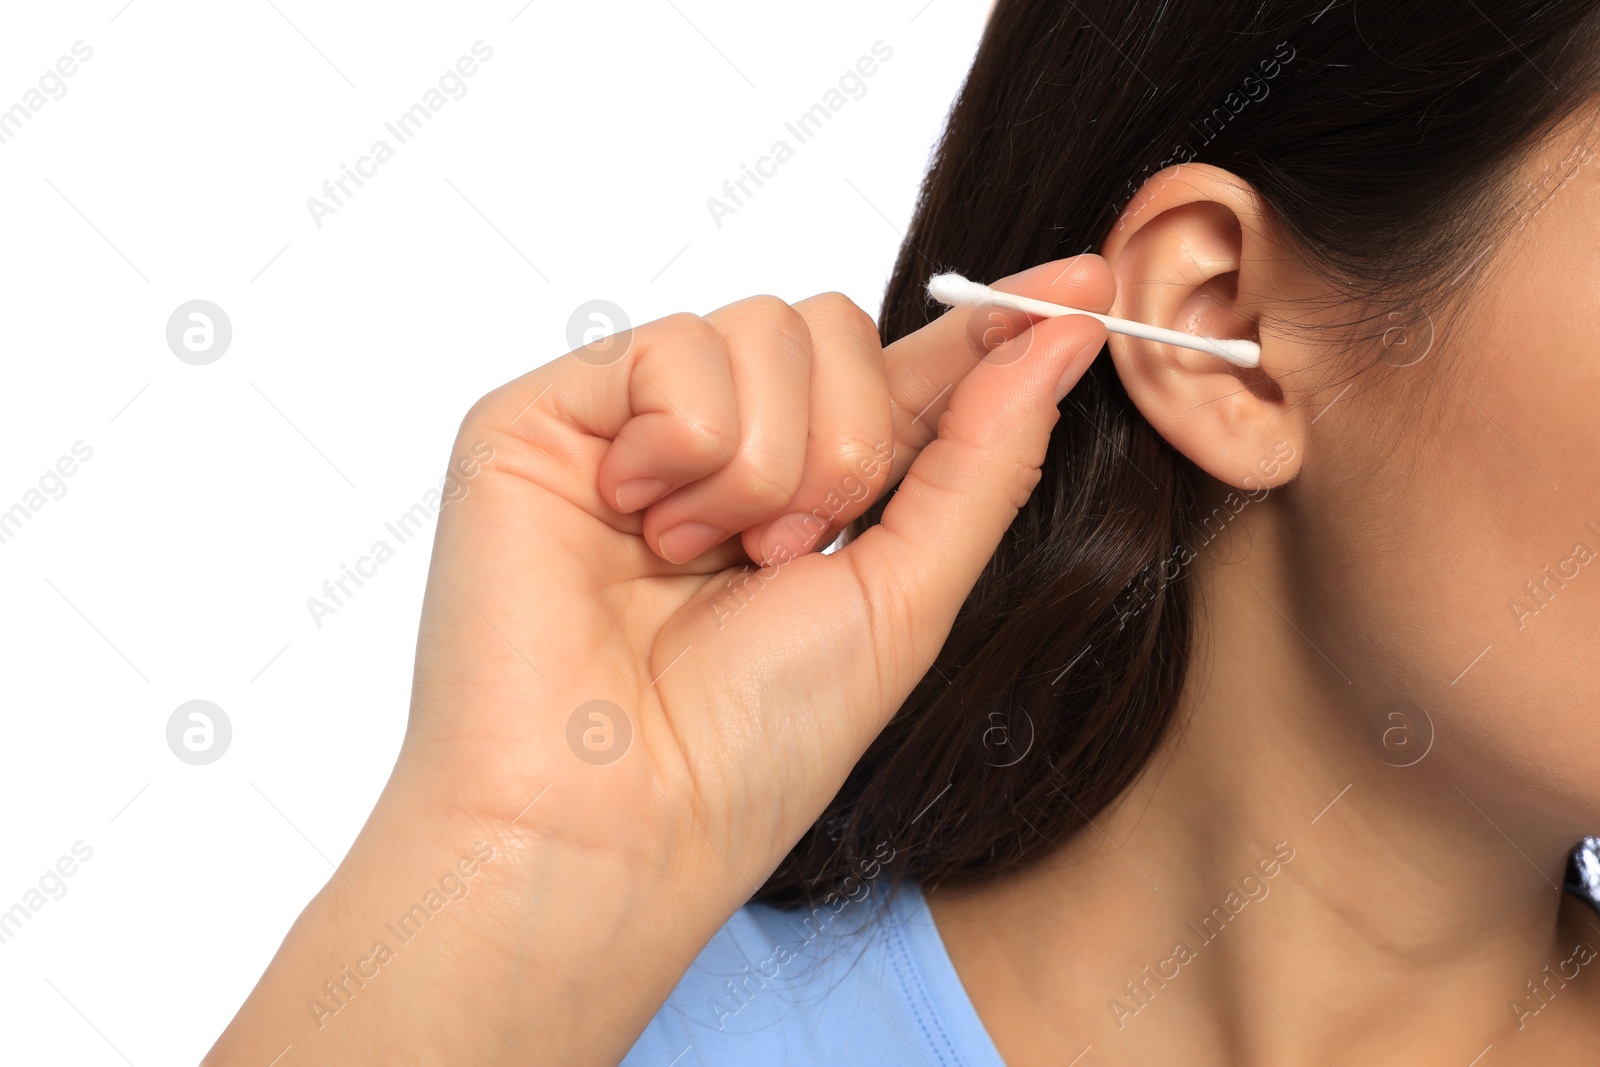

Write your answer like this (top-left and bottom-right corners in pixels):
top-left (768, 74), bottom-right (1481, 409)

top-left (1294, 194), bottom-right (1600, 819)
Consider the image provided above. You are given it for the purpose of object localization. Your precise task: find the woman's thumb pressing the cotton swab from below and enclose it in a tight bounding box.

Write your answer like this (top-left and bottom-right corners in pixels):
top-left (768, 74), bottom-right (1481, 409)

top-left (835, 287), bottom-right (1106, 697)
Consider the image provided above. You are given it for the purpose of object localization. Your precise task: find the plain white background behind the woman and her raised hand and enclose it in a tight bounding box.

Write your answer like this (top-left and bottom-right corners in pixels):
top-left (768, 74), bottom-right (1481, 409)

top-left (0, 0), bottom-right (987, 1067)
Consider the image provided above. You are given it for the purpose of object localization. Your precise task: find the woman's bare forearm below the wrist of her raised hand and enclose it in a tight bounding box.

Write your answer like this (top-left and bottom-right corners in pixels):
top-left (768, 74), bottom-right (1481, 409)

top-left (205, 805), bottom-right (738, 1067)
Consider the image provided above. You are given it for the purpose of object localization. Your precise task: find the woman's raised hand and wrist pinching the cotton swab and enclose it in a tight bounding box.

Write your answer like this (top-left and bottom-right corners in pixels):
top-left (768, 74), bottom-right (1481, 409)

top-left (206, 256), bottom-right (1112, 1062)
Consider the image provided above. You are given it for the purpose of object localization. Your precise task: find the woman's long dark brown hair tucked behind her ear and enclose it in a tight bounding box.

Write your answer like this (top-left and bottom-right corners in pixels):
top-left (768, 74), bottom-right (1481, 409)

top-left (758, 0), bottom-right (1600, 904)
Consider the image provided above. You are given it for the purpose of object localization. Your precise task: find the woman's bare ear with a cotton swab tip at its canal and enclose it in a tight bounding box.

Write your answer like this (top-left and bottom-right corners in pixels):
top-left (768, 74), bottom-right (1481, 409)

top-left (1101, 163), bottom-right (1310, 490)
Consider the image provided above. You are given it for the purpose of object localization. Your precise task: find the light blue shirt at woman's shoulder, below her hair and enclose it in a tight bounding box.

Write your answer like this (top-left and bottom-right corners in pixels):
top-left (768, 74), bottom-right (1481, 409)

top-left (622, 881), bottom-right (1005, 1067)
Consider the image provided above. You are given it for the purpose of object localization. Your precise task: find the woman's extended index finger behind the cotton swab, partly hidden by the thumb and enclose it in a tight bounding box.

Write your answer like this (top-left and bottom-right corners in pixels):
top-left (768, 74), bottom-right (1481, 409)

top-left (883, 253), bottom-right (1117, 485)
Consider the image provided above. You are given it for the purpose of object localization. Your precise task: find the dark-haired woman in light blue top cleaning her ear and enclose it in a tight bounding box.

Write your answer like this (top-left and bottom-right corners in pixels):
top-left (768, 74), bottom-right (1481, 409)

top-left (208, 0), bottom-right (1600, 1067)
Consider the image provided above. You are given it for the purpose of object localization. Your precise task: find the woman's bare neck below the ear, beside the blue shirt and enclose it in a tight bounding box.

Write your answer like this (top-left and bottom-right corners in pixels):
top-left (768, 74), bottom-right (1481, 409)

top-left (928, 489), bottom-right (1600, 1067)
